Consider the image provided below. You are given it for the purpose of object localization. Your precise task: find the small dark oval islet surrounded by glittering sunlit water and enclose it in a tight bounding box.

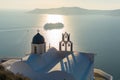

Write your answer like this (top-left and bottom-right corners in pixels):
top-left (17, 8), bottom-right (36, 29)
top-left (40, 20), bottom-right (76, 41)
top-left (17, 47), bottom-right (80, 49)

top-left (44, 23), bottom-right (64, 30)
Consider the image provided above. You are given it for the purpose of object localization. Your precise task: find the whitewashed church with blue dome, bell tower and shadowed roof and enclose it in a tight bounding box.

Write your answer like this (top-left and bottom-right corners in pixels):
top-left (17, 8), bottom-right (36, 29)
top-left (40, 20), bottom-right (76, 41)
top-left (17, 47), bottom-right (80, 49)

top-left (9, 33), bottom-right (94, 80)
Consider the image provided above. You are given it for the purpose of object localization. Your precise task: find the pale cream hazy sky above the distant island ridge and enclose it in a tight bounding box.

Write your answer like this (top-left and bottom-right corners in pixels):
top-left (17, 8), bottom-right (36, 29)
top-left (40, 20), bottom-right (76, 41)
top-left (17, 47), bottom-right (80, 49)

top-left (0, 0), bottom-right (120, 9)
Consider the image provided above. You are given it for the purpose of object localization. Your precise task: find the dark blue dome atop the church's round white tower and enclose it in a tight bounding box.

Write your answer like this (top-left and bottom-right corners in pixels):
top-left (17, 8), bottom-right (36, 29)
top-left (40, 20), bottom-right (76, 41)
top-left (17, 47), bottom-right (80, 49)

top-left (32, 33), bottom-right (45, 44)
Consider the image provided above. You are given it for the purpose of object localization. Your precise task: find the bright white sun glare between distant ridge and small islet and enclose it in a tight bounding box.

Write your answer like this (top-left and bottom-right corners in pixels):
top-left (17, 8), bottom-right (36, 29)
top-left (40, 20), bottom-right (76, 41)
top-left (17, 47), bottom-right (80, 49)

top-left (47, 15), bottom-right (64, 23)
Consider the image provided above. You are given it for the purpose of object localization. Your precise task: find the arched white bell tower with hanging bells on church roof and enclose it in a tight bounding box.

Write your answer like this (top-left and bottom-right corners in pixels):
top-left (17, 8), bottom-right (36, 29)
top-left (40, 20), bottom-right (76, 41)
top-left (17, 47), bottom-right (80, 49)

top-left (59, 32), bottom-right (73, 51)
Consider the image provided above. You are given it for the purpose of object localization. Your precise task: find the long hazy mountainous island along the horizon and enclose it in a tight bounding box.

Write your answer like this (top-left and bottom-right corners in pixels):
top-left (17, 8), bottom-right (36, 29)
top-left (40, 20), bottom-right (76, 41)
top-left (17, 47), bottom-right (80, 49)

top-left (28, 7), bottom-right (120, 16)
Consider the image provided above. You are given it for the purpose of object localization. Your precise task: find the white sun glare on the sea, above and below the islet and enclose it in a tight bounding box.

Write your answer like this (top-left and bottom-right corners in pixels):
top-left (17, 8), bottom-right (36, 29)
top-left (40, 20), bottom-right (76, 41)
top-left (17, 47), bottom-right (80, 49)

top-left (44, 15), bottom-right (64, 49)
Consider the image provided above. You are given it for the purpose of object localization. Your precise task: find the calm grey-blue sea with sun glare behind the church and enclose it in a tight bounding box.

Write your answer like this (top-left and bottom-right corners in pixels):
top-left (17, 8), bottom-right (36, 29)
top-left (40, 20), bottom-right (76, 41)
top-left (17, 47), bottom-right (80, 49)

top-left (0, 11), bottom-right (120, 80)
